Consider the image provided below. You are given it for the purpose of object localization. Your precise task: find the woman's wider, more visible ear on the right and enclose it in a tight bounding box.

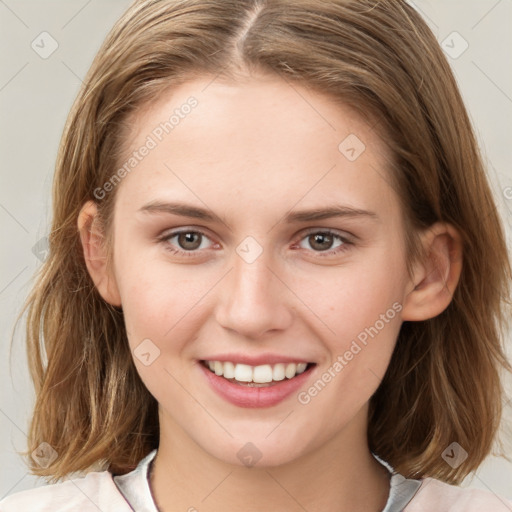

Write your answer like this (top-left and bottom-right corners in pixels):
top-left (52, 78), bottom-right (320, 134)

top-left (402, 222), bottom-right (462, 321)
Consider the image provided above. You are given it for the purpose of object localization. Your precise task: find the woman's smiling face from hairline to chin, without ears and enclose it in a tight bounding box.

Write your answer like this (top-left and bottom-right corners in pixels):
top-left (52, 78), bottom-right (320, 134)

top-left (102, 72), bottom-right (409, 465)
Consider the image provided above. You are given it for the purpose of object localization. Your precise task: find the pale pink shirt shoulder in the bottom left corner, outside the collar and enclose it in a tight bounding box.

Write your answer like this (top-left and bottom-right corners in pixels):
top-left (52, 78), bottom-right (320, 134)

top-left (0, 471), bottom-right (132, 512)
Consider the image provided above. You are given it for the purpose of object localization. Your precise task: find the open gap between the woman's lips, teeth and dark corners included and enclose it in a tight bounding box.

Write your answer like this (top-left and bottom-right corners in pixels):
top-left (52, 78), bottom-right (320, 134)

top-left (199, 359), bottom-right (316, 388)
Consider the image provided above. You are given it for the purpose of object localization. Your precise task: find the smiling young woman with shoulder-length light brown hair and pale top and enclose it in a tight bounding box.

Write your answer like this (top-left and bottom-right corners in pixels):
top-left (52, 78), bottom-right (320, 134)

top-left (0, 0), bottom-right (512, 512)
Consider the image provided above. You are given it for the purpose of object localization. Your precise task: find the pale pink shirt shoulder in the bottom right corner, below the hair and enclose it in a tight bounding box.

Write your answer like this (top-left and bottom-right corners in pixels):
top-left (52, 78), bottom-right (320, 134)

top-left (404, 478), bottom-right (512, 512)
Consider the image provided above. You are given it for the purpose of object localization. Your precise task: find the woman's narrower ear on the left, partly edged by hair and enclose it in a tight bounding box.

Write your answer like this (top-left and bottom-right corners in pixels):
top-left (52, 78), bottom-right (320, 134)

top-left (77, 201), bottom-right (121, 306)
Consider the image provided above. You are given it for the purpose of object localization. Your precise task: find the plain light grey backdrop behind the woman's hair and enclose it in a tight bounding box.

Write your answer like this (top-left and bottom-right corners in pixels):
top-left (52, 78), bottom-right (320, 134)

top-left (0, 0), bottom-right (512, 499)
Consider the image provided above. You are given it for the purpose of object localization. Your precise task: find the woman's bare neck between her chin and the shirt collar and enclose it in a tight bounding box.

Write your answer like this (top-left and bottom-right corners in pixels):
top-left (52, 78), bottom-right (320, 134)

top-left (150, 408), bottom-right (390, 512)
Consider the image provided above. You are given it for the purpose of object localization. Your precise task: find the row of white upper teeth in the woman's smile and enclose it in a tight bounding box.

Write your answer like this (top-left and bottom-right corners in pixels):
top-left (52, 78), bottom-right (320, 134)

top-left (205, 361), bottom-right (307, 383)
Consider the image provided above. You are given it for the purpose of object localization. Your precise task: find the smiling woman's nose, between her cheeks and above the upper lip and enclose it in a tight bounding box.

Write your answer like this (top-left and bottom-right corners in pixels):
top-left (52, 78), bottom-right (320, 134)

top-left (216, 246), bottom-right (293, 339)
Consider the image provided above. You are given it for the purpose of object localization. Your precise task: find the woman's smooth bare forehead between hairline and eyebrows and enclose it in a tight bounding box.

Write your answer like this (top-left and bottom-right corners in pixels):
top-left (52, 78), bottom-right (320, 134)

top-left (114, 76), bottom-right (393, 218)
